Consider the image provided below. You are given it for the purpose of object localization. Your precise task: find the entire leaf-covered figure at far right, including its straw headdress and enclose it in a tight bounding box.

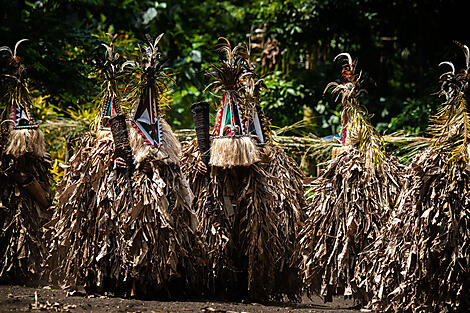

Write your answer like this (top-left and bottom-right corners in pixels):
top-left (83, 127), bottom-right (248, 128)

top-left (357, 42), bottom-right (470, 312)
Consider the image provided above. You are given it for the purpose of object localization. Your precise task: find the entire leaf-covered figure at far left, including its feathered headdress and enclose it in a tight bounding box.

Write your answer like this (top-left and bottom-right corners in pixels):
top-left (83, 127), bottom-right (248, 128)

top-left (0, 39), bottom-right (51, 284)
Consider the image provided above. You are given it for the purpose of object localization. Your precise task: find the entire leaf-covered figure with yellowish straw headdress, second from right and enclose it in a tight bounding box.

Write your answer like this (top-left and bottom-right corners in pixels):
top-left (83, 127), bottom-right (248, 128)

top-left (300, 53), bottom-right (401, 301)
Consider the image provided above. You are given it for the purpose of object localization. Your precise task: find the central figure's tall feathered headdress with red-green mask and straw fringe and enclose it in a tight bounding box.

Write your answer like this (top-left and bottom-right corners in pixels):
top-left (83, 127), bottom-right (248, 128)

top-left (206, 38), bottom-right (266, 167)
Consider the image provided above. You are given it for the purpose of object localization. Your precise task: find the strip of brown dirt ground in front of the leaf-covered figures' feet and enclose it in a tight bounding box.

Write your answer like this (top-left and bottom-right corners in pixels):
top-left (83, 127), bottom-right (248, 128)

top-left (0, 286), bottom-right (360, 313)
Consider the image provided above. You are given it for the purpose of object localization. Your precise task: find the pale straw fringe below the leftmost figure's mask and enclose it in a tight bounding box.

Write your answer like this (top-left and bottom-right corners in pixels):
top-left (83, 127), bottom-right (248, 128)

top-left (5, 129), bottom-right (46, 158)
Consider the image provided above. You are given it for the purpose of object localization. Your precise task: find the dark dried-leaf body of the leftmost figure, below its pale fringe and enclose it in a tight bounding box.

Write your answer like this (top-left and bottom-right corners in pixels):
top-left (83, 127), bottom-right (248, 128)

top-left (0, 133), bottom-right (51, 285)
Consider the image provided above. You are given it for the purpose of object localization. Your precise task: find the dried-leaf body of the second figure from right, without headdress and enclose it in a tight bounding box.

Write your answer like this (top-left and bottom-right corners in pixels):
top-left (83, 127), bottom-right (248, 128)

top-left (299, 148), bottom-right (402, 301)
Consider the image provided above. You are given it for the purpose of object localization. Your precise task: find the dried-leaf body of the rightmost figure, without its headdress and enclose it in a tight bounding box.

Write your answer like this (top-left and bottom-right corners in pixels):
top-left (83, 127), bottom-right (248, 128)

top-left (357, 150), bottom-right (470, 312)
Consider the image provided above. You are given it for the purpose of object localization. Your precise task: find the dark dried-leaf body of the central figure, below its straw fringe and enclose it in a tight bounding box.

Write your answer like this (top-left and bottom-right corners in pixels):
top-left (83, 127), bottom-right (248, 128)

top-left (182, 140), bottom-right (305, 300)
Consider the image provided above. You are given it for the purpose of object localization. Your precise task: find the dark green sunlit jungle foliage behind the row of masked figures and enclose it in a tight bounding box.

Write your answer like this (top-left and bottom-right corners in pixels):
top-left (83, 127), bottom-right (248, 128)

top-left (0, 0), bottom-right (469, 179)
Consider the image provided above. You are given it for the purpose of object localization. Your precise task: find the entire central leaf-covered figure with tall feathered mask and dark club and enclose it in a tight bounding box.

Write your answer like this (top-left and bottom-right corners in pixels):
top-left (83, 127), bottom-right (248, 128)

top-left (182, 38), bottom-right (304, 300)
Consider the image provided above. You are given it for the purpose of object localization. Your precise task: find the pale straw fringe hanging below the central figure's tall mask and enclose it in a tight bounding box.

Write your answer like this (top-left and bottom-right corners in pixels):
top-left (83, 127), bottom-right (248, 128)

top-left (209, 136), bottom-right (260, 168)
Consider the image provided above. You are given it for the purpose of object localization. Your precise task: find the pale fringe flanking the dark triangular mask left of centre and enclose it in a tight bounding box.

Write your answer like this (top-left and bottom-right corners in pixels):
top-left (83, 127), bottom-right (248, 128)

top-left (128, 119), bottom-right (181, 165)
